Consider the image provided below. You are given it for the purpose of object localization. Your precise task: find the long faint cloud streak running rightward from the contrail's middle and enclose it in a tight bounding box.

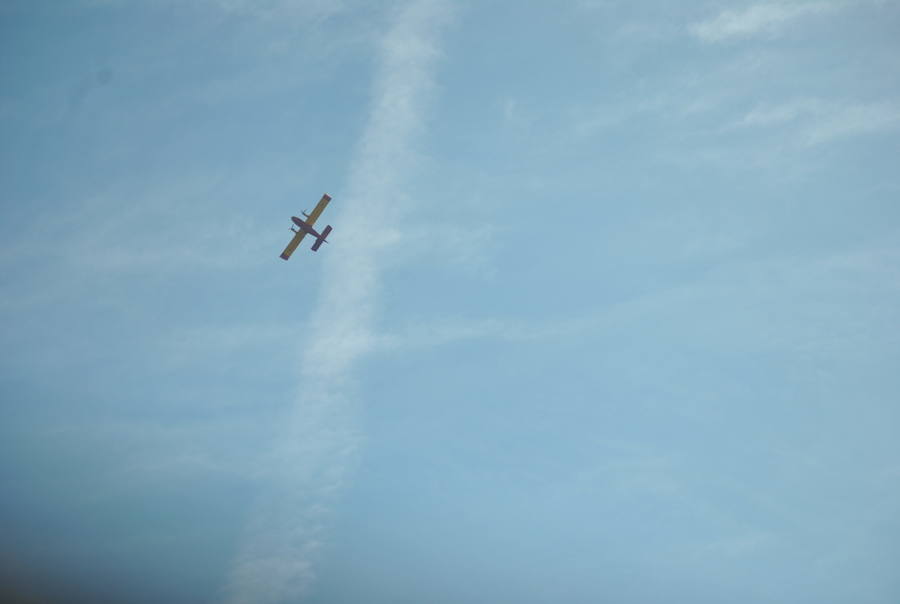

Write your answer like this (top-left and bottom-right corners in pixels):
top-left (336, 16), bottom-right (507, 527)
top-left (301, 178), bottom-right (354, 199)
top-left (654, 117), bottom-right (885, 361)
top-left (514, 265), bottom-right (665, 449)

top-left (371, 230), bottom-right (900, 360)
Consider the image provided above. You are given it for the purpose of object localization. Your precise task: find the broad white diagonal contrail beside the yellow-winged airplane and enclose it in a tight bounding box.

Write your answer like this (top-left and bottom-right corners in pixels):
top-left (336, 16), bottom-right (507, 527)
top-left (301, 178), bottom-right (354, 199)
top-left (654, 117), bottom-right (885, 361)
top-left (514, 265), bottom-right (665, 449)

top-left (226, 0), bottom-right (448, 604)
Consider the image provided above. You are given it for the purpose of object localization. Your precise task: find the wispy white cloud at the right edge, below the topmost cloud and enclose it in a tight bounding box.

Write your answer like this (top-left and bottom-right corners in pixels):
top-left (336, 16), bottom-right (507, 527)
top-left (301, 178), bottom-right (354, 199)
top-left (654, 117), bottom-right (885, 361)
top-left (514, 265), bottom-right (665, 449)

top-left (738, 99), bottom-right (900, 145)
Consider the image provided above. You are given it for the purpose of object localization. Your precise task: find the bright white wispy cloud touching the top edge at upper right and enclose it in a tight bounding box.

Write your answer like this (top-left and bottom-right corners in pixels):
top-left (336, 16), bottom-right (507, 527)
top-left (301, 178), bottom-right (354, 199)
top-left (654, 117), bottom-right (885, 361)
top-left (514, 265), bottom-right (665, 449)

top-left (690, 1), bottom-right (846, 42)
